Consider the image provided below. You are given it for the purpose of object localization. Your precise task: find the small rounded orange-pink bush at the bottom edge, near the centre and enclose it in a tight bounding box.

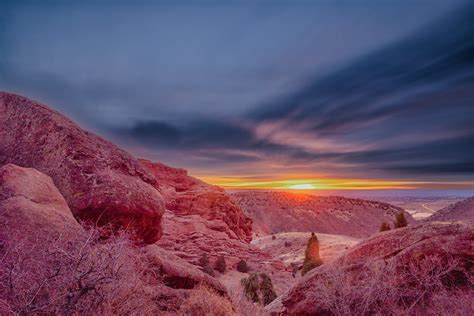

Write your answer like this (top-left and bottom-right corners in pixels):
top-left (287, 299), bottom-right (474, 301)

top-left (179, 285), bottom-right (236, 316)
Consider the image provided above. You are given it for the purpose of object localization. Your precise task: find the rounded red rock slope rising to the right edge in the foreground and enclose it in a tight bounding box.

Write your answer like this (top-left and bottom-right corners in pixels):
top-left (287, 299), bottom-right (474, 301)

top-left (268, 222), bottom-right (474, 315)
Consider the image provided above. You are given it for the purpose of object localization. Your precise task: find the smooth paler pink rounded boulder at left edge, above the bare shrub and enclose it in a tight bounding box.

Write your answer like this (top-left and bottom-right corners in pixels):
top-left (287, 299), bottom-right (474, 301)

top-left (0, 164), bottom-right (82, 242)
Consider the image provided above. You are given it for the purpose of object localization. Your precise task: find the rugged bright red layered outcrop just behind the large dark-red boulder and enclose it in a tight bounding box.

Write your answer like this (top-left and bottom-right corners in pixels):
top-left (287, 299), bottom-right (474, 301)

top-left (140, 160), bottom-right (252, 242)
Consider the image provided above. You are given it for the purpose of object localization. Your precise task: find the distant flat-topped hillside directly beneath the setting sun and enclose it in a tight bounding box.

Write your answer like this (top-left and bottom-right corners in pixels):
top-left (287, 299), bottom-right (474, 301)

top-left (231, 191), bottom-right (414, 238)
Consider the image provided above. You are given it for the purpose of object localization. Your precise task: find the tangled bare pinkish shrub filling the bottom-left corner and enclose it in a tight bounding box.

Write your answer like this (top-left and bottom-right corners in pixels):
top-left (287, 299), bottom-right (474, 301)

top-left (0, 229), bottom-right (151, 314)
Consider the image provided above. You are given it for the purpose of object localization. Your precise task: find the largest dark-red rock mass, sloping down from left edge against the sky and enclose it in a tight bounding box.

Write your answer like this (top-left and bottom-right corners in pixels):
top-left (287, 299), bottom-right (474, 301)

top-left (0, 92), bottom-right (164, 243)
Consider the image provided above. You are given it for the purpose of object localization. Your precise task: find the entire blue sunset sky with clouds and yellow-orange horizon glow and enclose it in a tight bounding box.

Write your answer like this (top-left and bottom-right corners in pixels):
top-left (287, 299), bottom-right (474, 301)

top-left (0, 0), bottom-right (474, 190)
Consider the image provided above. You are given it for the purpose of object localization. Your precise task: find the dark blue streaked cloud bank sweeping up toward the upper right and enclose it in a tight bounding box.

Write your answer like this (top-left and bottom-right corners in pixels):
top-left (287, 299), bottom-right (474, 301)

top-left (0, 0), bottom-right (474, 180)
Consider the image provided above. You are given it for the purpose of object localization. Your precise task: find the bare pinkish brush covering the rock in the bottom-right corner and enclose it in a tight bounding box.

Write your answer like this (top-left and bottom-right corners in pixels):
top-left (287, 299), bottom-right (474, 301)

top-left (298, 255), bottom-right (474, 315)
